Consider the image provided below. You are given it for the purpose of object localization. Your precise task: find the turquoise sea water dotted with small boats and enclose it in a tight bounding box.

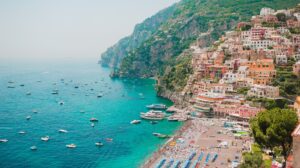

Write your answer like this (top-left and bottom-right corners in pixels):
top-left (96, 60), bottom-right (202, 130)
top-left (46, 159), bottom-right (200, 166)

top-left (0, 60), bottom-right (180, 168)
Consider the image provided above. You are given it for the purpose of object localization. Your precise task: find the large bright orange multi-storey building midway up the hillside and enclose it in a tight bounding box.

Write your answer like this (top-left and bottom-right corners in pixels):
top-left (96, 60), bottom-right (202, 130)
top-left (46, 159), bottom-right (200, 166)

top-left (247, 59), bottom-right (276, 85)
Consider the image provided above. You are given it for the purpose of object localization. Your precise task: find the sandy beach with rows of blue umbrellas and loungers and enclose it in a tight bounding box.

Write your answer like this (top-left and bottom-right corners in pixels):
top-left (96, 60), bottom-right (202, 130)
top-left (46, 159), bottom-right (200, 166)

top-left (141, 118), bottom-right (251, 168)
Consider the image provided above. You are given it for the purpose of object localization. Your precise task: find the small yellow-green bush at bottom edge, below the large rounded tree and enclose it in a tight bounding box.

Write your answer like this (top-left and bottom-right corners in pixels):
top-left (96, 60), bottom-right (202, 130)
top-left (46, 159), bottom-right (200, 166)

top-left (239, 152), bottom-right (263, 168)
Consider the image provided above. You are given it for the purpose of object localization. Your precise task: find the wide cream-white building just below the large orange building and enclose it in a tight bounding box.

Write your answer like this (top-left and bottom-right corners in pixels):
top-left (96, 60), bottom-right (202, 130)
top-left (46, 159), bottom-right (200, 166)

top-left (247, 85), bottom-right (279, 99)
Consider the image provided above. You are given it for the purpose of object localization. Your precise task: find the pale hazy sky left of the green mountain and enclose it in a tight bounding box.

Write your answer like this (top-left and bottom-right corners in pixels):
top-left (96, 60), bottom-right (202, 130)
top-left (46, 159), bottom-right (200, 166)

top-left (0, 0), bottom-right (179, 62)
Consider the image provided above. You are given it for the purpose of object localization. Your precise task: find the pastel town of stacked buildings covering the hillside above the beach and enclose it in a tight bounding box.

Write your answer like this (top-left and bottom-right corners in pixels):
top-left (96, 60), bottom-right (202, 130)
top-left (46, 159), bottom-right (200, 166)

top-left (182, 5), bottom-right (300, 167)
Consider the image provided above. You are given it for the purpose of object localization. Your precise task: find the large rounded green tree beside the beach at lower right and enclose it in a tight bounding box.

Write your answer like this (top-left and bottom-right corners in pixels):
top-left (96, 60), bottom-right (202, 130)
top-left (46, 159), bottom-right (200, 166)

top-left (250, 108), bottom-right (298, 159)
